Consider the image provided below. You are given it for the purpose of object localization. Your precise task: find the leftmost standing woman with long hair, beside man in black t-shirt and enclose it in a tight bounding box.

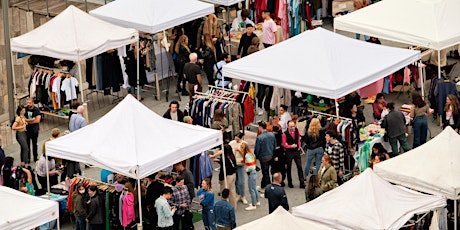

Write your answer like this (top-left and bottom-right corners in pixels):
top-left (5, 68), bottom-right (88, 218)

top-left (11, 106), bottom-right (30, 167)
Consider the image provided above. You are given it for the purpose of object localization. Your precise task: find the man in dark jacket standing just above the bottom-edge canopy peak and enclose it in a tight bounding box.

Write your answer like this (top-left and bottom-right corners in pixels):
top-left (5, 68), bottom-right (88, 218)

top-left (265, 173), bottom-right (289, 214)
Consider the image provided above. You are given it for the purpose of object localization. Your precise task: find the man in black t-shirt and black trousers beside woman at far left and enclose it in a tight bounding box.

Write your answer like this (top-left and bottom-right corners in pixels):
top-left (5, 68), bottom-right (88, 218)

top-left (25, 98), bottom-right (42, 162)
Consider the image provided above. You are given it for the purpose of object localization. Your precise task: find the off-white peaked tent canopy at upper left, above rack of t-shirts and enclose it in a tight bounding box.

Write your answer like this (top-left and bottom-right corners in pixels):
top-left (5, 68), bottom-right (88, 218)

top-left (11, 5), bottom-right (138, 61)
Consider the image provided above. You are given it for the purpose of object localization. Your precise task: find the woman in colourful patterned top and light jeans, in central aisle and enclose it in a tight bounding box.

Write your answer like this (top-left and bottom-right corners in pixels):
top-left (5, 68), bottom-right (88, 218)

top-left (240, 143), bottom-right (260, 210)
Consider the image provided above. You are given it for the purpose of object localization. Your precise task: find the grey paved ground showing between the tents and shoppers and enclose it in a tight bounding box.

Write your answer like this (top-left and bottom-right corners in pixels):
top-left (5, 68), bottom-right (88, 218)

top-left (1, 17), bottom-right (460, 229)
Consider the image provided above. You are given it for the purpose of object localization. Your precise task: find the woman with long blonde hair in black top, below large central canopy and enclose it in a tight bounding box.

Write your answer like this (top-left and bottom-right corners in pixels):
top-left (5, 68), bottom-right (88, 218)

top-left (303, 118), bottom-right (326, 180)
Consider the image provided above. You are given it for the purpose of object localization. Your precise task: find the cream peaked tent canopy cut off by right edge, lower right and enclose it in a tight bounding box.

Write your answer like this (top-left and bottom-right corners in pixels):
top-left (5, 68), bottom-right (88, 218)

top-left (374, 127), bottom-right (460, 200)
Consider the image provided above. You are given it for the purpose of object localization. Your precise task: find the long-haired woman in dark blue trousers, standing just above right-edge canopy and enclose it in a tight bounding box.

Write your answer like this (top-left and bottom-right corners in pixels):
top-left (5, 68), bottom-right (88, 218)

top-left (410, 93), bottom-right (430, 149)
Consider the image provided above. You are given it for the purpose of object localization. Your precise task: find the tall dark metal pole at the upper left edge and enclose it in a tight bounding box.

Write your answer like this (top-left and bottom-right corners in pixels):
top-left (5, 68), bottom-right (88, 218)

top-left (2, 0), bottom-right (14, 121)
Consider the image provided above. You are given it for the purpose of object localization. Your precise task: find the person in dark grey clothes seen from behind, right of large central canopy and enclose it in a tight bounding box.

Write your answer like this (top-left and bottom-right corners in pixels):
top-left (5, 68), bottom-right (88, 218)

top-left (382, 102), bottom-right (410, 156)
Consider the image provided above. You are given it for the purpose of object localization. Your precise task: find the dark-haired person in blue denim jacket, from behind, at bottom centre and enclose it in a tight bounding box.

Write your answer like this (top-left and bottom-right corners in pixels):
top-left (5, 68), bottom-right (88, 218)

top-left (214, 189), bottom-right (236, 230)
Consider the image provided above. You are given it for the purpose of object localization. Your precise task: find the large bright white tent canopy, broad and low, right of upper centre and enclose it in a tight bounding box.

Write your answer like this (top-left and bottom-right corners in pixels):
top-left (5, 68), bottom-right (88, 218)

top-left (223, 28), bottom-right (420, 99)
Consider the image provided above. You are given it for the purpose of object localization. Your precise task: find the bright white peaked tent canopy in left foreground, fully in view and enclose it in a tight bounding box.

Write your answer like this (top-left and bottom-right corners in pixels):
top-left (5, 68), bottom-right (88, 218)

top-left (46, 95), bottom-right (222, 179)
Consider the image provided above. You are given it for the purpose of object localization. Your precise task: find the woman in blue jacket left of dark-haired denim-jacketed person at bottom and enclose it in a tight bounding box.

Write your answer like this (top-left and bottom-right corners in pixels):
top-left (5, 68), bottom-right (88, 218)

top-left (197, 178), bottom-right (216, 230)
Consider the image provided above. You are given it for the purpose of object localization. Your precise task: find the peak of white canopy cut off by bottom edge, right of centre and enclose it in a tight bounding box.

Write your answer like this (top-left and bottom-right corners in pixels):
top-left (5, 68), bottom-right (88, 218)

top-left (235, 206), bottom-right (334, 230)
